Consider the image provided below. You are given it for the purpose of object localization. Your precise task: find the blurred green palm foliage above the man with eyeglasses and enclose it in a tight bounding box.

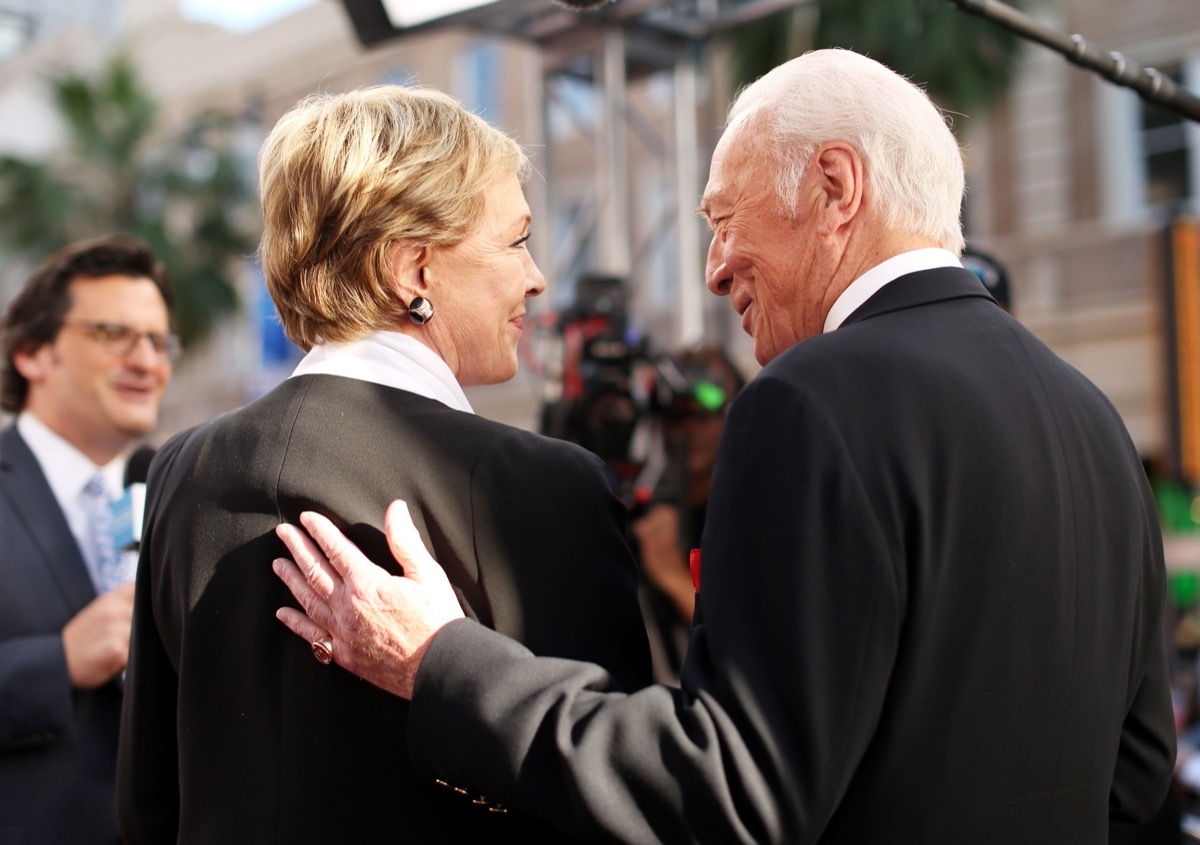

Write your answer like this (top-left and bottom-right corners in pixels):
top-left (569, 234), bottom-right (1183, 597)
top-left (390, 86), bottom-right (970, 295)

top-left (0, 56), bottom-right (258, 349)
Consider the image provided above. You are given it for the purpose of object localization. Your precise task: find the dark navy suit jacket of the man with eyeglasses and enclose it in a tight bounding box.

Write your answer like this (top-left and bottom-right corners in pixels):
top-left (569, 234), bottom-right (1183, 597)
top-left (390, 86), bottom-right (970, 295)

top-left (0, 426), bottom-right (121, 845)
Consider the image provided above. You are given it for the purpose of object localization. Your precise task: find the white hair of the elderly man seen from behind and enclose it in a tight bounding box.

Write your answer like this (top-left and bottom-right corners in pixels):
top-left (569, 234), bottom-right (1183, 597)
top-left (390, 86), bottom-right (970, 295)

top-left (728, 49), bottom-right (966, 253)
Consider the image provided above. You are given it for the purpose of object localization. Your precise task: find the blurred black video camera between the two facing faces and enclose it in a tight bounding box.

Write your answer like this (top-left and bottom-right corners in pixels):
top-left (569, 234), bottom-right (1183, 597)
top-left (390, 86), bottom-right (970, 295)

top-left (539, 275), bottom-right (726, 508)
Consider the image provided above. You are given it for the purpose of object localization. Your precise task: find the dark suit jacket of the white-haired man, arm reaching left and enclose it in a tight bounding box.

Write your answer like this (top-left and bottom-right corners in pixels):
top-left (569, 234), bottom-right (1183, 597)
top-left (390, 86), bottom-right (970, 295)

top-left (400, 269), bottom-right (1175, 845)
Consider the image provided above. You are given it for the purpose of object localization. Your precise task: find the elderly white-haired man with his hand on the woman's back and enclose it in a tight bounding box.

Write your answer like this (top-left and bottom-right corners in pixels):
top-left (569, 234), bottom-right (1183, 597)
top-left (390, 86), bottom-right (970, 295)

top-left (275, 50), bottom-right (1175, 845)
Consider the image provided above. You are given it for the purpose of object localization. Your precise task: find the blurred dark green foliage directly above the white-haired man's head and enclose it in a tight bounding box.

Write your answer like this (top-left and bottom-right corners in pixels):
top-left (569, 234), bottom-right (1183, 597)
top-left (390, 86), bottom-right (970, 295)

top-left (732, 0), bottom-right (1022, 117)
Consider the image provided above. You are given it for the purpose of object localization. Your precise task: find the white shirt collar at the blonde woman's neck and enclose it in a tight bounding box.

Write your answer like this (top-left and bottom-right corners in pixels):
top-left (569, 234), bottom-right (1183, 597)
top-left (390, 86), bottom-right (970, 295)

top-left (292, 331), bottom-right (475, 414)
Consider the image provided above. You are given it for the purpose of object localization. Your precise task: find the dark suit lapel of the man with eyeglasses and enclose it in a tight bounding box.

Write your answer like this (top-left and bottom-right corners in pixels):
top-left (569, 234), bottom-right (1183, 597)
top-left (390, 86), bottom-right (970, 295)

top-left (0, 426), bottom-right (96, 607)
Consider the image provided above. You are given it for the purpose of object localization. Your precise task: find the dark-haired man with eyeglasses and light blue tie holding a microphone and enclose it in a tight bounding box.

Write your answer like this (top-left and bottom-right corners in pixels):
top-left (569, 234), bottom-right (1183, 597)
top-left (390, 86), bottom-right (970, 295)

top-left (0, 235), bottom-right (178, 845)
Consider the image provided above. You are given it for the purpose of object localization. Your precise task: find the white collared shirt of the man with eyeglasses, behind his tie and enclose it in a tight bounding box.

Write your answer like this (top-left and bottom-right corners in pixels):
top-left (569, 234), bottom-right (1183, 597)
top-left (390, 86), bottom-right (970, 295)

top-left (17, 410), bottom-right (128, 580)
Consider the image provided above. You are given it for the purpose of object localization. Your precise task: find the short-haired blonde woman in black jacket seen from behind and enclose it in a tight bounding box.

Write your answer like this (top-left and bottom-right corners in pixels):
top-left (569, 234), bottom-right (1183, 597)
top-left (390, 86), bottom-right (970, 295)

top-left (119, 86), bottom-right (649, 845)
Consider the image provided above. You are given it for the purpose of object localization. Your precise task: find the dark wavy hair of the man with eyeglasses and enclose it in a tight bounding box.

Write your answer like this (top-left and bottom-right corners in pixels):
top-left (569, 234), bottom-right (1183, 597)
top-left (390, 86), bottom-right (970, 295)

top-left (0, 234), bottom-right (170, 413)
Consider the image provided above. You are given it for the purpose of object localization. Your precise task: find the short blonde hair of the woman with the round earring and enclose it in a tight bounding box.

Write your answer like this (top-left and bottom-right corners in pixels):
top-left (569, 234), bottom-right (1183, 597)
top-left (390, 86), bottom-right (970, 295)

top-left (259, 85), bottom-right (529, 349)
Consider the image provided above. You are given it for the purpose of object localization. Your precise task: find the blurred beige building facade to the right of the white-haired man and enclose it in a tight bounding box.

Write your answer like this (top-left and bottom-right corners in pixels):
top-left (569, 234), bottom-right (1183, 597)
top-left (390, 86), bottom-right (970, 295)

top-left (965, 0), bottom-right (1200, 468)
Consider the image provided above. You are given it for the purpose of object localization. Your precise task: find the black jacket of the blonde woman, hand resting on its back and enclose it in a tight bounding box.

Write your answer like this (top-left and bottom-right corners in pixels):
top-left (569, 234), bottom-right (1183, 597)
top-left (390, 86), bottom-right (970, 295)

top-left (118, 376), bottom-right (649, 844)
